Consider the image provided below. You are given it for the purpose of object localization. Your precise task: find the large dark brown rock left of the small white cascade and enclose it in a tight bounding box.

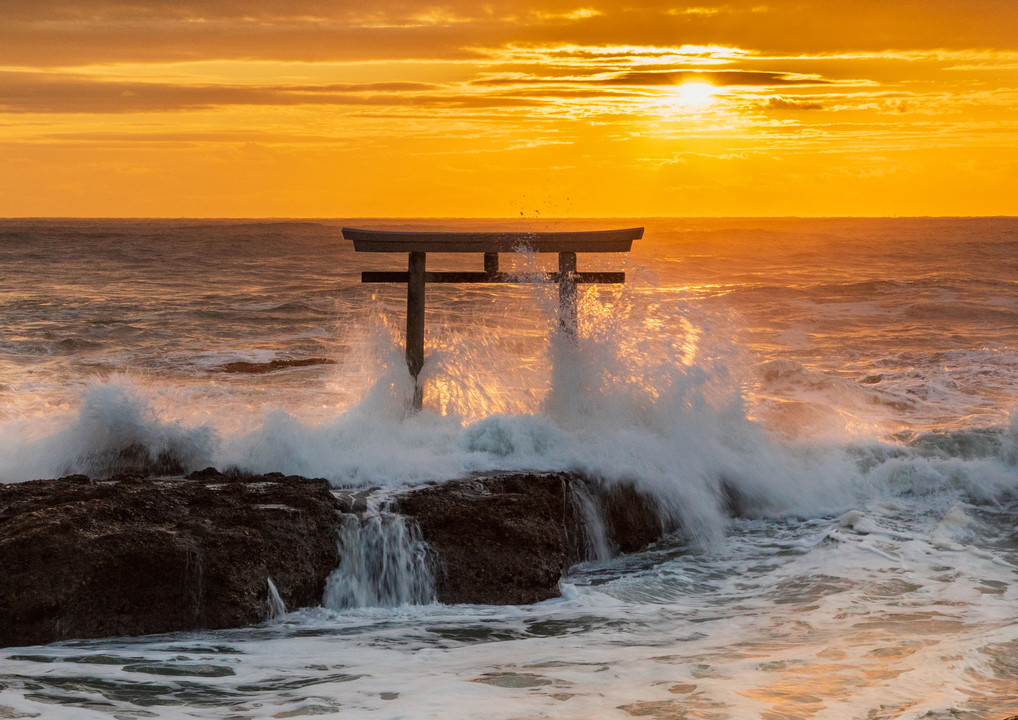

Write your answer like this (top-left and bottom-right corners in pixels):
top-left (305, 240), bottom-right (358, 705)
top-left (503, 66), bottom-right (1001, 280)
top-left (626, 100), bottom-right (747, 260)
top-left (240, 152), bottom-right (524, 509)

top-left (0, 469), bottom-right (339, 646)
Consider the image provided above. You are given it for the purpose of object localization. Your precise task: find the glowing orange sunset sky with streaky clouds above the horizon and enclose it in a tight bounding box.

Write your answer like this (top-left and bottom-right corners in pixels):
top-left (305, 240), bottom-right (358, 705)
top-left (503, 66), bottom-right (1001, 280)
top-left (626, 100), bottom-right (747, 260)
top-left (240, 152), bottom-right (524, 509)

top-left (0, 0), bottom-right (1018, 219)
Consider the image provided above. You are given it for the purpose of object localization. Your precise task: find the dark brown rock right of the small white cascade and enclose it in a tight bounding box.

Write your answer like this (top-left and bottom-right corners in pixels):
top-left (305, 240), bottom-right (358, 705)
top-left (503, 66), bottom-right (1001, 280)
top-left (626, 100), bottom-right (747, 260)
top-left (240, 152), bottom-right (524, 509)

top-left (396, 473), bottom-right (675, 605)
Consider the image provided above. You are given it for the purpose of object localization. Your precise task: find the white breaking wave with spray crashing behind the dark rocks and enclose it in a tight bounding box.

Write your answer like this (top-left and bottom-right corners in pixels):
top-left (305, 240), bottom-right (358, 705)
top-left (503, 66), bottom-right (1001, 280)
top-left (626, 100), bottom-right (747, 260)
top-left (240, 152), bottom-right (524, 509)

top-left (0, 297), bottom-right (1018, 547)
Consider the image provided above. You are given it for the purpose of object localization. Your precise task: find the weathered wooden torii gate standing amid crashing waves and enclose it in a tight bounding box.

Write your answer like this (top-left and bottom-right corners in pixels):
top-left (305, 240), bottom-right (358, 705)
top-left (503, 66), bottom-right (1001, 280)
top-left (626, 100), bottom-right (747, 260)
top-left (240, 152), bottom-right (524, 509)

top-left (343, 227), bottom-right (643, 410)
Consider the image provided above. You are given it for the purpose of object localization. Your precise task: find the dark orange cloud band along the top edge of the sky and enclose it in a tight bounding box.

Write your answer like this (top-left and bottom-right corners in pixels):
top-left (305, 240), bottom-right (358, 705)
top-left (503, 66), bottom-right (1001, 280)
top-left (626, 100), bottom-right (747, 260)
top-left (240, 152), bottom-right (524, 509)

top-left (0, 0), bottom-right (1018, 67)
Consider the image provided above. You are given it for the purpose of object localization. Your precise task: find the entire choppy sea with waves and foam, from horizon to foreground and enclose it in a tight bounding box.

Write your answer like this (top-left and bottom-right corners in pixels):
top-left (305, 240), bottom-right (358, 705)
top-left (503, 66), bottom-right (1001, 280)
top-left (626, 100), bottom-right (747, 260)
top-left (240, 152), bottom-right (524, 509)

top-left (0, 218), bottom-right (1018, 720)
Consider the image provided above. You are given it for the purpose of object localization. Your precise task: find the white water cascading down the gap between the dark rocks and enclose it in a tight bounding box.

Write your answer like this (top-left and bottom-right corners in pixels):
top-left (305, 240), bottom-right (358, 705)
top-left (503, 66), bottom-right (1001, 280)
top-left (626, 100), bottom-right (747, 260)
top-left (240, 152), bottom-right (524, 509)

top-left (322, 498), bottom-right (435, 610)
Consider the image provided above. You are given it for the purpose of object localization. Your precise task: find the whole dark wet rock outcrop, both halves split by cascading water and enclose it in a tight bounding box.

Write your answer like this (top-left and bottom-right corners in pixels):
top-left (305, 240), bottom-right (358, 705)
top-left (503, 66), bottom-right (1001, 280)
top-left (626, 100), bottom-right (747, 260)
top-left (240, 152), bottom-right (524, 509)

top-left (0, 468), bottom-right (674, 646)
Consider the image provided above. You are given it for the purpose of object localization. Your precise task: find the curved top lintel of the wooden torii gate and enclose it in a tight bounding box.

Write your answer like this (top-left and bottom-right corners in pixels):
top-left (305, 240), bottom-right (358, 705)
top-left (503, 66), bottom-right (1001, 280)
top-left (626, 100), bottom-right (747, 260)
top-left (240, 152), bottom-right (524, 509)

top-left (343, 227), bottom-right (643, 253)
